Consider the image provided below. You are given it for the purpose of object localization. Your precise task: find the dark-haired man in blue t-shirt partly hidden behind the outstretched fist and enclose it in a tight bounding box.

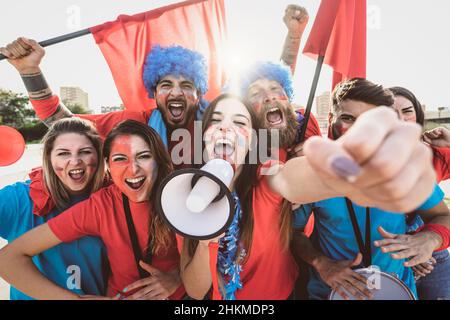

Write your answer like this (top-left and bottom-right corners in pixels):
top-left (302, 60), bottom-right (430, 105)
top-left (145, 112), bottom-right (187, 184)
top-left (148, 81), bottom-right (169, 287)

top-left (294, 79), bottom-right (450, 299)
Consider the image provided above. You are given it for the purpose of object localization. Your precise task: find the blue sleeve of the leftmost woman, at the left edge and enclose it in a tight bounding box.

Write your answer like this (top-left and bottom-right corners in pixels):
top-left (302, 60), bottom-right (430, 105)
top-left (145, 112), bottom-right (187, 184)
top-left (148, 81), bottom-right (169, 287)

top-left (0, 182), bottom-right (31, 240)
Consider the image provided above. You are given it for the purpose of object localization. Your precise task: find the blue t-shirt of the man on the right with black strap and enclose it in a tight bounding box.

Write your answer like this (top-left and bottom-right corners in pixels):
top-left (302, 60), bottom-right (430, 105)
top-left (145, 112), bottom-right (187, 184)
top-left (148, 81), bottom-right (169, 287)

top-left (294, 185), bottom-right (444, 299)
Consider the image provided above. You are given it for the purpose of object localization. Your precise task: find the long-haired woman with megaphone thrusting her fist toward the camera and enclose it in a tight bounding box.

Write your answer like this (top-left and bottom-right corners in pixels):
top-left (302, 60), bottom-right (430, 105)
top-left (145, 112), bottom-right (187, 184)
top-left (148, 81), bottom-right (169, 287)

top-left (181, 95), bottom-right (440, 299)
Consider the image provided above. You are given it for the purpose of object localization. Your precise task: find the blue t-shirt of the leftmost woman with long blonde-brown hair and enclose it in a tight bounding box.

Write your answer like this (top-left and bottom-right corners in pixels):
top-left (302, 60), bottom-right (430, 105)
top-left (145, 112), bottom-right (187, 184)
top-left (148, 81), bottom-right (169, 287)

top-left (0, 181), bottom-right (109, 300)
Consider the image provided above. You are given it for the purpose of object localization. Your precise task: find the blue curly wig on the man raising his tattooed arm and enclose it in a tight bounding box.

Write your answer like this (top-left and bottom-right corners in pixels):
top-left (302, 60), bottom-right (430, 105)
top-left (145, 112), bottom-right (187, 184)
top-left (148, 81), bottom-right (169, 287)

top-left (142, 45), bottom-right (208, 99)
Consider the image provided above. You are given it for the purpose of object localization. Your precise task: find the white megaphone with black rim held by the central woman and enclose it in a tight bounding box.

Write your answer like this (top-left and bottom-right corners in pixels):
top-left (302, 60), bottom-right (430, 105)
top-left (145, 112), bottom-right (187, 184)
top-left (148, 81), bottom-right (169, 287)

top-left (156, 159), bottom-right (234, 240)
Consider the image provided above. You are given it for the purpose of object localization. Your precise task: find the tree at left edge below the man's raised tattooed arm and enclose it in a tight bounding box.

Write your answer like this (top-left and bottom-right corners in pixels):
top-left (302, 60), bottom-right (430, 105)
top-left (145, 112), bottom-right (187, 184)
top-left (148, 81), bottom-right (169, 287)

top-left (0, 89), bottom-right (39, 128)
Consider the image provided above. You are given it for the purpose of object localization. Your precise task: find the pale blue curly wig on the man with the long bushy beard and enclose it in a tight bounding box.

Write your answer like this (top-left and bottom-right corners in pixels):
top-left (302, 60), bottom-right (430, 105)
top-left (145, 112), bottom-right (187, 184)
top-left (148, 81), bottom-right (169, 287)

top-left (239, 61), bottom-right (294, 101)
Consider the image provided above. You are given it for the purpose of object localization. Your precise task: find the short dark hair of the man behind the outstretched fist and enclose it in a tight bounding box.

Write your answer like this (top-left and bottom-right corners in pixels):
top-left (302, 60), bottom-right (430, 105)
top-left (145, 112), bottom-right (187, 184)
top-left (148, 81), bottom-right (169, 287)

top-left (331, 78), bottom-right (394, 109)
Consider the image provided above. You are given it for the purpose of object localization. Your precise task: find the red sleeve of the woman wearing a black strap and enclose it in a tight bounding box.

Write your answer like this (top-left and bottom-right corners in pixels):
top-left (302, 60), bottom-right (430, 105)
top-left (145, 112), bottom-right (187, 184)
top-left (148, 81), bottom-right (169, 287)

top-left (48, 189), bottom-right (104, 242)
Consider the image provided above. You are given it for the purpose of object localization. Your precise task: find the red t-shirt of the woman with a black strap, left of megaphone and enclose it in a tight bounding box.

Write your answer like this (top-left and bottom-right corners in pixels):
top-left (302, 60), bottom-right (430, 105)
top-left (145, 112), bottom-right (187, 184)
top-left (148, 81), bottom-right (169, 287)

top-left (48, 184), bottom-right (185, 299)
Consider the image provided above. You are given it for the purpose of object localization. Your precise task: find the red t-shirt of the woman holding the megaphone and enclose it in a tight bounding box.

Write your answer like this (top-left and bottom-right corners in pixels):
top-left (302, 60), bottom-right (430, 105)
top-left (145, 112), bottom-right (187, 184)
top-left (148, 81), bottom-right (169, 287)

top-left (236, 167), bottom-right (298, 300)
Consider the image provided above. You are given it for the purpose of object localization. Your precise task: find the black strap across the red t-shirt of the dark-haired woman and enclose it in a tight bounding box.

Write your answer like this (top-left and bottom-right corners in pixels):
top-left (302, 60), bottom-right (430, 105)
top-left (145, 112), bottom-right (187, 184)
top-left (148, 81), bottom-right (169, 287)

top-left (122, 193), bottom-right (153, 279)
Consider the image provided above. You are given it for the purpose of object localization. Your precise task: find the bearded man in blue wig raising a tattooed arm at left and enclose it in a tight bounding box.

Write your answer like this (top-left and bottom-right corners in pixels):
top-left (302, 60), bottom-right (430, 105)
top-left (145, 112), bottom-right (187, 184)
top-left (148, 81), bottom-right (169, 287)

top-left (0, 38), bottom-right (208, 166)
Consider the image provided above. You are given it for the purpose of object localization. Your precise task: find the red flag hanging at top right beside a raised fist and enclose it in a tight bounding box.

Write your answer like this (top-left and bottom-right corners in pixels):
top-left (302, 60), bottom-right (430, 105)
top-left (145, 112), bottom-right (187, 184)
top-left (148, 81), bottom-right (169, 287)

top-left (303, 0), bottom-right (367, 88)
